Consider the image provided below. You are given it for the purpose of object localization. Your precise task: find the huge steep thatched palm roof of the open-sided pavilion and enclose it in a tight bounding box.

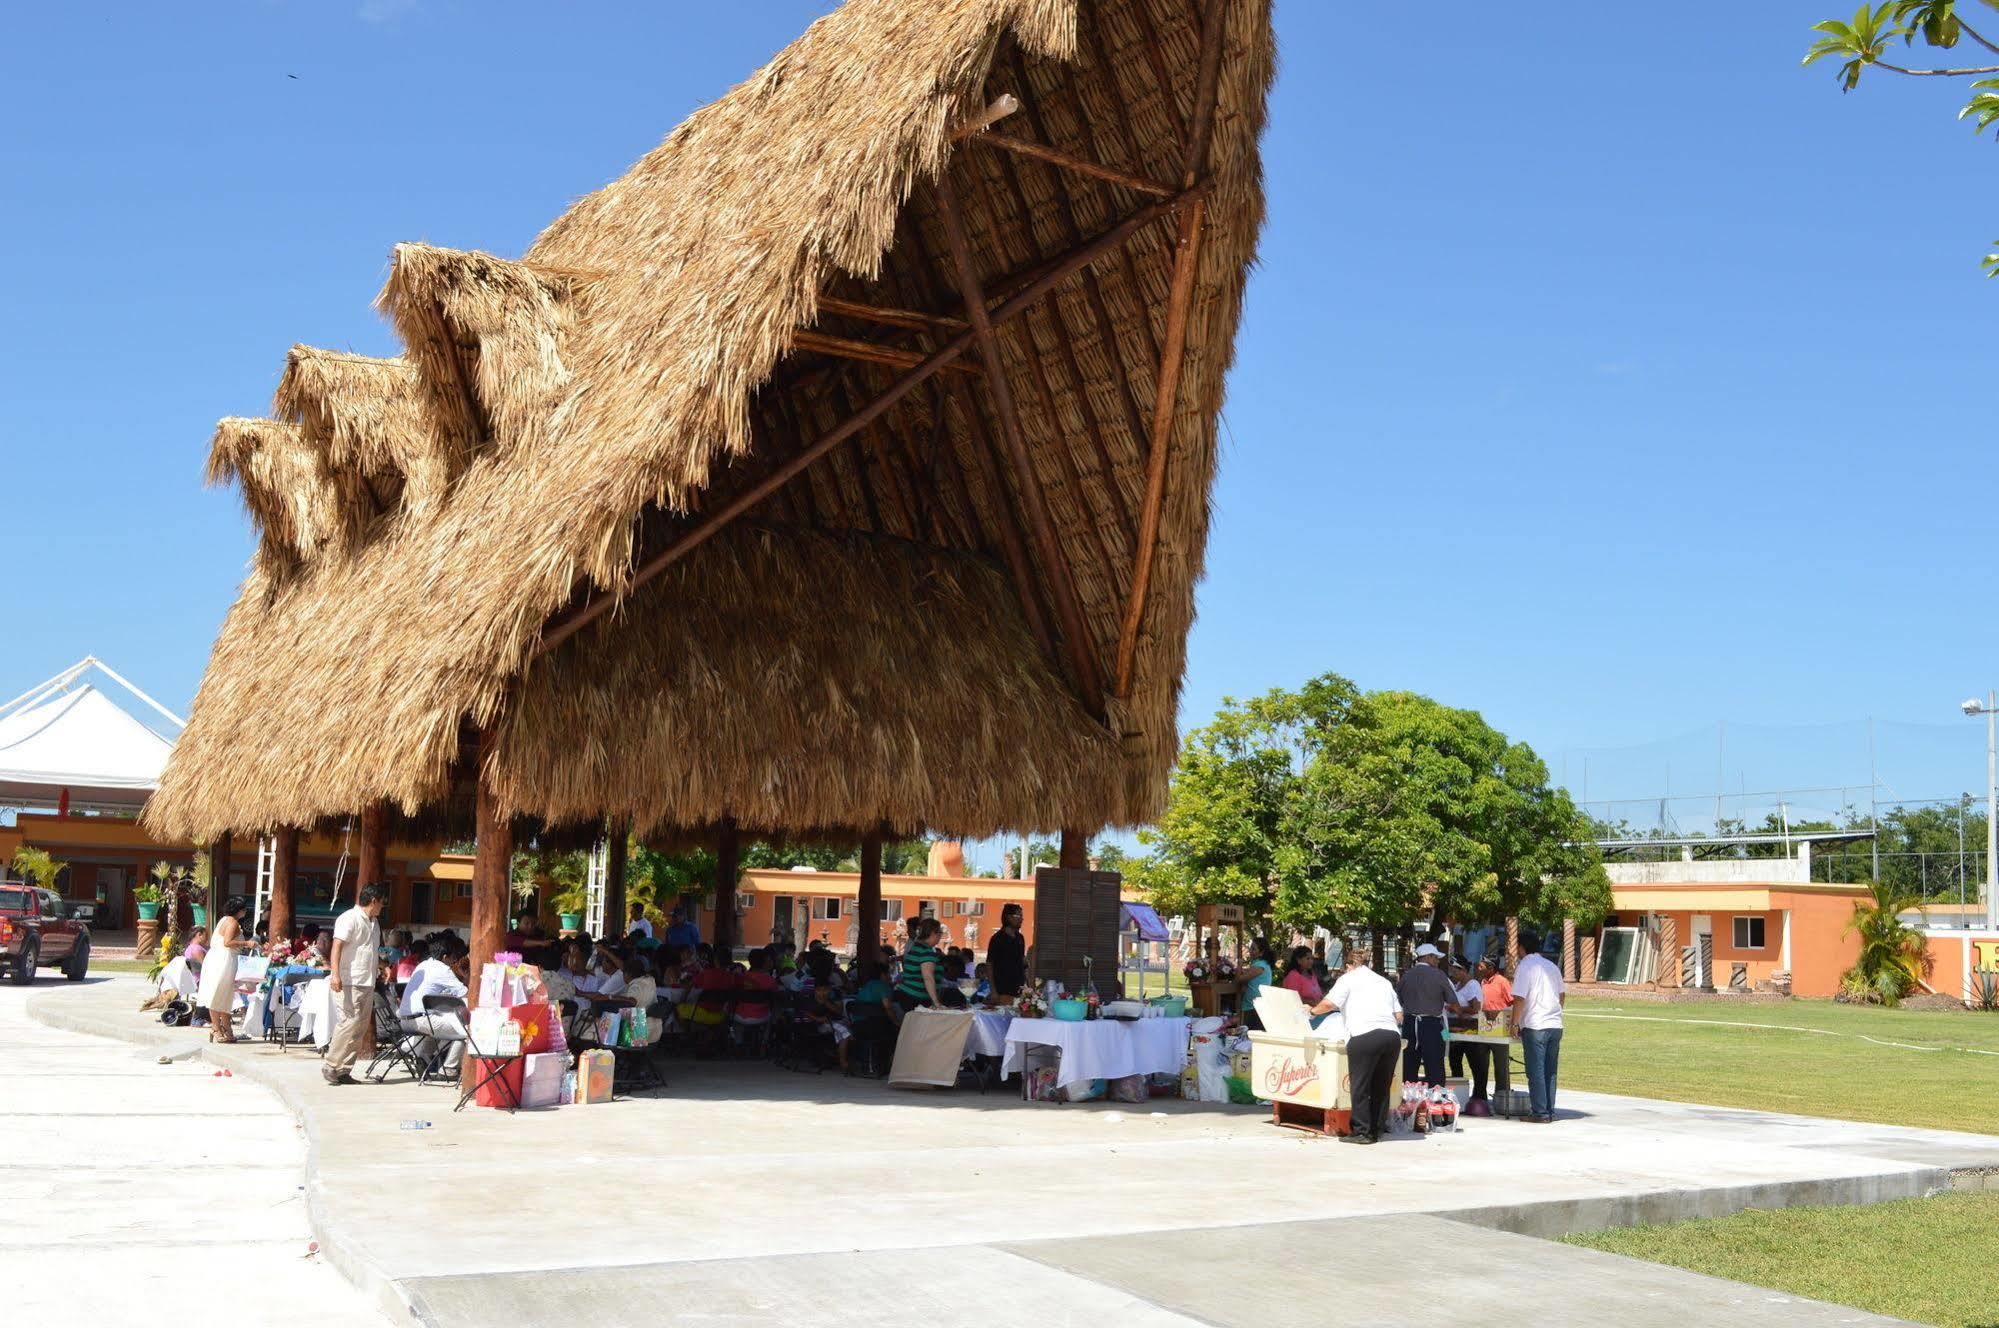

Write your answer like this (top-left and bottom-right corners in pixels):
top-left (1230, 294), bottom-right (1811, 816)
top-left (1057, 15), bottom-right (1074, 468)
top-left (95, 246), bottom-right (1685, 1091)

top-left (148, 0), bottom-right (1273, 836)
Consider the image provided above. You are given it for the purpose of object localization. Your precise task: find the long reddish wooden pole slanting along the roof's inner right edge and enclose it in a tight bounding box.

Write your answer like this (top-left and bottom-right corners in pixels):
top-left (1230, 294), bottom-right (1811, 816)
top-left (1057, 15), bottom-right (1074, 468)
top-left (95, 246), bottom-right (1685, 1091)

top-left (1113, 0), bottom-right (1225, 698)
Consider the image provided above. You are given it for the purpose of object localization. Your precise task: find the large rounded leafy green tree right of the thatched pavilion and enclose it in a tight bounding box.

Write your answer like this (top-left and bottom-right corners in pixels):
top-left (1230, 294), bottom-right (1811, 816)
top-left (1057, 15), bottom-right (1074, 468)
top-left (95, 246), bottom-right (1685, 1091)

top-left (1127, 674), bottom-right (1609, 928)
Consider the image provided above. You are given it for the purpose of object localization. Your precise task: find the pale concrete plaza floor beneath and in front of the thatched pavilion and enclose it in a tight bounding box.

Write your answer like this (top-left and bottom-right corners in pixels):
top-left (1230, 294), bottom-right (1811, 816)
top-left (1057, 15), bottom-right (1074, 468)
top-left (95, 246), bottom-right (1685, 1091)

top-left (19, 980), bottom-right (1999, 1328)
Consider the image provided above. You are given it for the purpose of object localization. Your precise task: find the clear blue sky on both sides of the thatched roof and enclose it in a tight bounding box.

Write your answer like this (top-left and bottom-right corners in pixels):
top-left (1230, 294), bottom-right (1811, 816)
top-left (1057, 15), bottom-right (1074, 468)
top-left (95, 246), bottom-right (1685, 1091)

top-left (0, 0), bottom-right (1999, 840)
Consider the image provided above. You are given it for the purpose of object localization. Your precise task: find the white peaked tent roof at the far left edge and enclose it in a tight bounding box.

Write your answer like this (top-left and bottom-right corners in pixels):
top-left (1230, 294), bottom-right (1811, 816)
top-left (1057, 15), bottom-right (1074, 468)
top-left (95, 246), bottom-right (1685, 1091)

top-left (0, 658), bottom-right (178, 808)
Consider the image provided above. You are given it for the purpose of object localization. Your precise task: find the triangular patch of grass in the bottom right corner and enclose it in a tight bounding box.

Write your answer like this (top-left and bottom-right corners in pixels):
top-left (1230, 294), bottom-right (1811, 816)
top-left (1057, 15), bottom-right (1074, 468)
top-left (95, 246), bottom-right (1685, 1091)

top-left (1563, 1192), bottom-right (1999, 1328)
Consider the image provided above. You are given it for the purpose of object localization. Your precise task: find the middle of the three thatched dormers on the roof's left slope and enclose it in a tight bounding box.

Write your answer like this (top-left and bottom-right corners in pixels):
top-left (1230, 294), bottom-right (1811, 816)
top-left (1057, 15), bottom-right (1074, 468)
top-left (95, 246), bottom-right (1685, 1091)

top-left (272, 346), bottom-right (452, 530)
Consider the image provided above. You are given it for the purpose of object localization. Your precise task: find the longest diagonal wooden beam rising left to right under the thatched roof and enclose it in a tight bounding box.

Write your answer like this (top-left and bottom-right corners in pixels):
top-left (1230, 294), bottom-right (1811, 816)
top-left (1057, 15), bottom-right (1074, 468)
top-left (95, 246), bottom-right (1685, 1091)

top-left (534, 184), bottom-right (1205, 656)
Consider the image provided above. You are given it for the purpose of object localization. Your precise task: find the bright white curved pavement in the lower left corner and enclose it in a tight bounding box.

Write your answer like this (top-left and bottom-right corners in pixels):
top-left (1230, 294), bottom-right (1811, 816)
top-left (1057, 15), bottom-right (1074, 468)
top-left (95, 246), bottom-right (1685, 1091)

top-left (0, 978), bottom-right (386, 1328)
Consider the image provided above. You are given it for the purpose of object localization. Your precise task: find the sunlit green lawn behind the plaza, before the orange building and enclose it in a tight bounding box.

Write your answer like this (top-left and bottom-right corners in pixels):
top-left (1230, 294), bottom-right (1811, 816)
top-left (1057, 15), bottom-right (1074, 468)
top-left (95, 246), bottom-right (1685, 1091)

top-left (1559, 998), bottom-right (1999, 1128)
